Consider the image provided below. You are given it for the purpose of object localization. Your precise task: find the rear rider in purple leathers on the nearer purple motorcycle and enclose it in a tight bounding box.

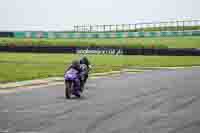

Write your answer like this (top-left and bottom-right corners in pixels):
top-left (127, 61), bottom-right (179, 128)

top-left (65, 60), bottom-right (82, 97)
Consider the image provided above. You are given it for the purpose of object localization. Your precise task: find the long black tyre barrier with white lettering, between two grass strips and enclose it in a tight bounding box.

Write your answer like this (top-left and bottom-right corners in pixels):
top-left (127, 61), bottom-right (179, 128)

top-left (0, 45), bottom-right (200, 56)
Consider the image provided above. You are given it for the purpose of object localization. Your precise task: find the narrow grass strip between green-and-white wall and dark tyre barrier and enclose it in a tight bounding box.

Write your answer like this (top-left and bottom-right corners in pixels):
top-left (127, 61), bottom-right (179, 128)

top-left (0, 37), bottom-right (200, 48)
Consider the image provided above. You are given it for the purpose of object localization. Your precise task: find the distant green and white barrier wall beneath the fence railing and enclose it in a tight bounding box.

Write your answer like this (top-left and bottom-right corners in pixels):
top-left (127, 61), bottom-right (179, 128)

top-left (13, 31), bottom-right (200, 39)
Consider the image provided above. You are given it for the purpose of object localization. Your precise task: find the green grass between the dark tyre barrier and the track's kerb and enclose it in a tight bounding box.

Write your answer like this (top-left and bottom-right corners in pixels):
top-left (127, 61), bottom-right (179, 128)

top-left (0, 53), bottom-right (200, 83)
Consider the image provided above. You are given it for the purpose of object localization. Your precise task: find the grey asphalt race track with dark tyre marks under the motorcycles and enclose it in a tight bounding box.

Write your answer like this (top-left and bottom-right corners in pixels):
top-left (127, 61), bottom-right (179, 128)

top-left (0, 68), bottom-right (200, 133)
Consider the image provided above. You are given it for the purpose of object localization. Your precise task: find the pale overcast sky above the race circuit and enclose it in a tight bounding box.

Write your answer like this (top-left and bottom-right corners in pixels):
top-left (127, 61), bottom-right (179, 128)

top-left (0, 0), bottom-right (200, 30)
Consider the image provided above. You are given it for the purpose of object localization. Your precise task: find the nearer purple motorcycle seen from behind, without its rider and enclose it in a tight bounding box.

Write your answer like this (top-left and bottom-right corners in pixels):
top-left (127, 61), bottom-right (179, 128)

top-left (64, 69), bottom-right (80, 99)
